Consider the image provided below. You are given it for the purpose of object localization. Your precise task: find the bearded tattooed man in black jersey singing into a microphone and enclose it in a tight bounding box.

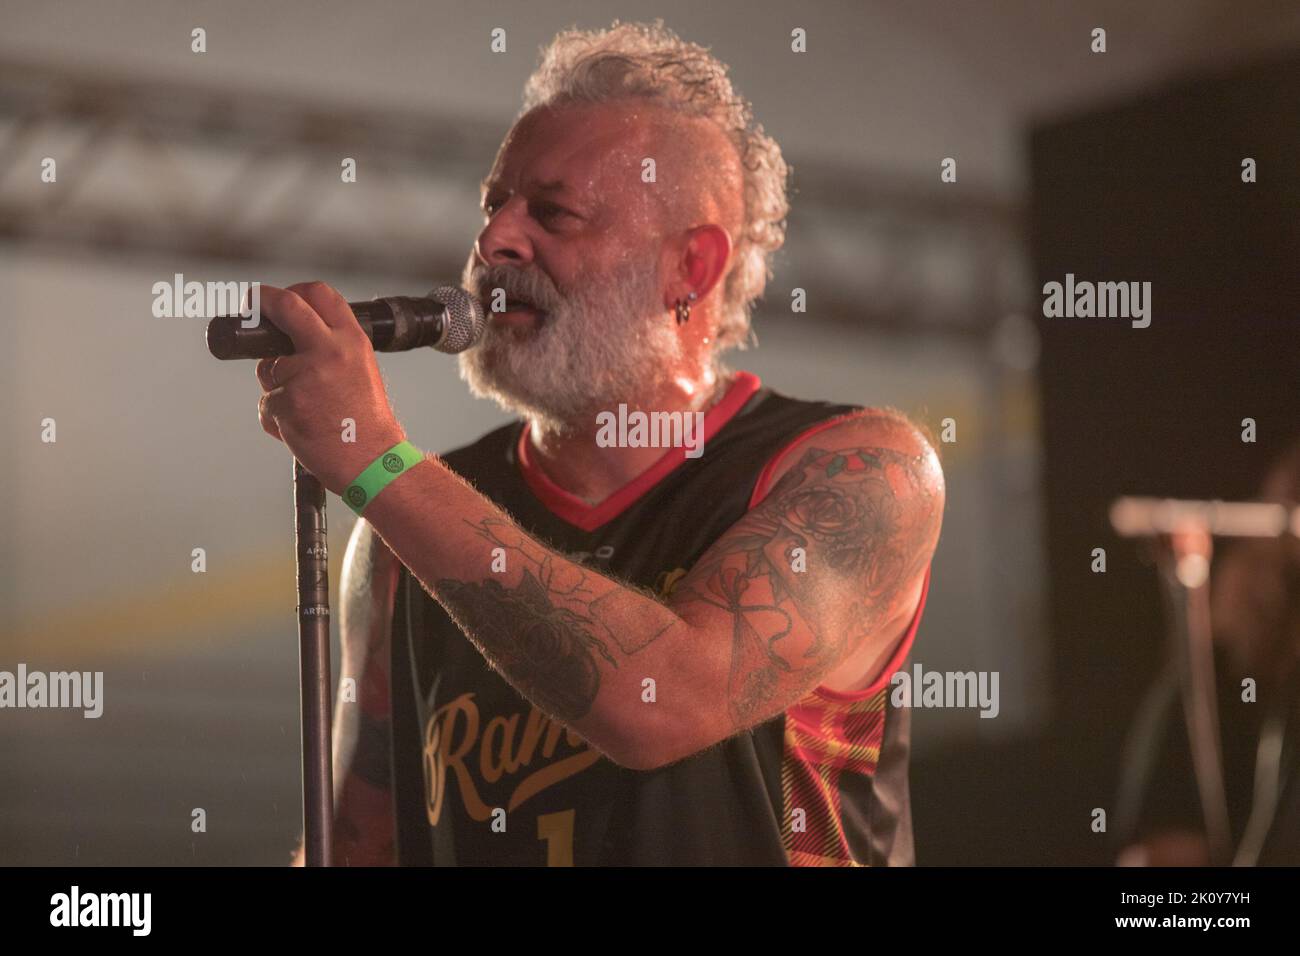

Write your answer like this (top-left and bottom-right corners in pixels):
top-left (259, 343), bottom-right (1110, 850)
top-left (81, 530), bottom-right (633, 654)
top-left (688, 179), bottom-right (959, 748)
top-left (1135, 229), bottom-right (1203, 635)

top-left (269, 23), bottom-right (944, 866)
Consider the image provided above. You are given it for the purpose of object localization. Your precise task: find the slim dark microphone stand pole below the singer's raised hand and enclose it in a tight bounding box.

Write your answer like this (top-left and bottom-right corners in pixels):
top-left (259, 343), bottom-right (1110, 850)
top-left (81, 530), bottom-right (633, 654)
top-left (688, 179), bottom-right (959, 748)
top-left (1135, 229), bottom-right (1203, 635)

top-left (294, 459), bottom-right (334, 866)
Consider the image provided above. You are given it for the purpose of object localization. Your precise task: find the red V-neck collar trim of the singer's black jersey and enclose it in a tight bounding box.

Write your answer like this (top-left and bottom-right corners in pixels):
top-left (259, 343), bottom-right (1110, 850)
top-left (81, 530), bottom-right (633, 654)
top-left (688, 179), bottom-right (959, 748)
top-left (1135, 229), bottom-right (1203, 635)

top-left (517, 372), bottom-right (762, 531)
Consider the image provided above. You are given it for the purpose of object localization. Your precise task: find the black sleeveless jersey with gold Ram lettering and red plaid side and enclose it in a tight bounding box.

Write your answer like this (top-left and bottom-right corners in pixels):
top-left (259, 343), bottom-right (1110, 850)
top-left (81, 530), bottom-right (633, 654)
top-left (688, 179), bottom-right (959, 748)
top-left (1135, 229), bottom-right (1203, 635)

top-left (391, 372), bottom-right (928, 866)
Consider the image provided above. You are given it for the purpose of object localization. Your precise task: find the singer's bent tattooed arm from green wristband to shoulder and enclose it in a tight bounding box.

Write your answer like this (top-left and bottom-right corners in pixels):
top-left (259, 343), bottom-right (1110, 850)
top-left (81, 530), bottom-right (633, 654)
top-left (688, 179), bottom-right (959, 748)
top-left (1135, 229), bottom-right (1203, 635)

top-left (367, 412), bottom-right (944, 769)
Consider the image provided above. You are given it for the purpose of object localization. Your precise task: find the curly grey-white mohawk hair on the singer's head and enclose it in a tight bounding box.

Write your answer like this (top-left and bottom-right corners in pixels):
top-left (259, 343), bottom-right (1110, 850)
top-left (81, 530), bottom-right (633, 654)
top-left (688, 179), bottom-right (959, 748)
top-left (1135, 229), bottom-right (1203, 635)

top-left (520, 20), bottom-right (789, 354)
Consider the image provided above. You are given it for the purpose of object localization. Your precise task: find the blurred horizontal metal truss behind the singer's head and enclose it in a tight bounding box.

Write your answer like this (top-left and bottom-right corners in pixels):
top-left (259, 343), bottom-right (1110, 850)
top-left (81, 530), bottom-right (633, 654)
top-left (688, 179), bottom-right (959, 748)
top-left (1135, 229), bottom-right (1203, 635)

top-left (0, 60), bottom-right (1026, 334)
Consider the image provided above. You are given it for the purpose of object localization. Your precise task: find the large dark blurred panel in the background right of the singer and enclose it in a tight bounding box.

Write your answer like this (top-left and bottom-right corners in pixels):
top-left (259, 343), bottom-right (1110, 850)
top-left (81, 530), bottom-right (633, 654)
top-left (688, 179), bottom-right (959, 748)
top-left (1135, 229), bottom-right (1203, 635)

top-left (913, 52), bottom-right (1300, 864)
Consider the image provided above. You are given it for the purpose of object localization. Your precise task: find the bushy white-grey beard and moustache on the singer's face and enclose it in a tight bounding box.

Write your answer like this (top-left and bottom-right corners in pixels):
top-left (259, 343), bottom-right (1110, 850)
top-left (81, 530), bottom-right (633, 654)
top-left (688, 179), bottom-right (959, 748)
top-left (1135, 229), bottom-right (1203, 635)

top-left (459, 254), bottom-right (681, 434)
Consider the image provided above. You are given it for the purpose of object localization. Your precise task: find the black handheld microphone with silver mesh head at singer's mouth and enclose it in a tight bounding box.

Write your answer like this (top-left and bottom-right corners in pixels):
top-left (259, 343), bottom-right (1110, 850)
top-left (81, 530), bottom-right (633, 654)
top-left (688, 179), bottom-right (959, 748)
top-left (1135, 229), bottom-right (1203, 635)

top-left (208, 285), bottom-right (486, 359)
